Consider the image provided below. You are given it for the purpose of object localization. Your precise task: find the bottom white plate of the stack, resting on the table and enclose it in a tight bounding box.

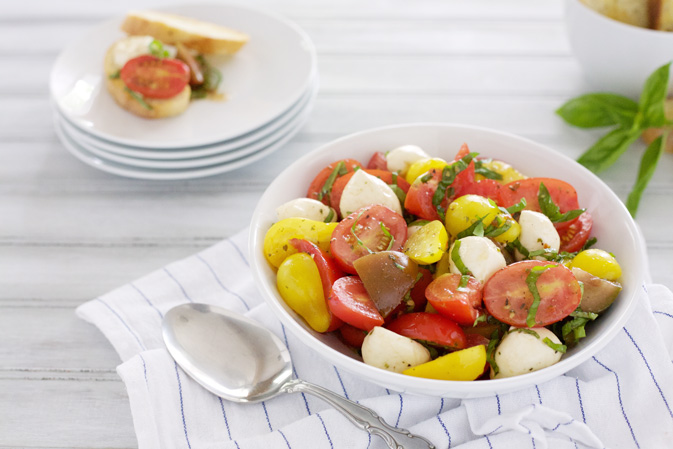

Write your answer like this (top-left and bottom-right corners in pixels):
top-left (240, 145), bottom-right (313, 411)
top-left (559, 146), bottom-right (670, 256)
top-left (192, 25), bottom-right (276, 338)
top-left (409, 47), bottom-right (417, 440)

top-left (54, 100), bottom-right (311, 181)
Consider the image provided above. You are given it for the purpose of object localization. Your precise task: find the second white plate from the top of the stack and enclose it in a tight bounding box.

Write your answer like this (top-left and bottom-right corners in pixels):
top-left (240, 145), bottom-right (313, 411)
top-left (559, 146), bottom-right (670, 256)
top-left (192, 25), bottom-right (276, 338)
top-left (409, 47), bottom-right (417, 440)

top-left (55, 77), bottom-right (317, 164)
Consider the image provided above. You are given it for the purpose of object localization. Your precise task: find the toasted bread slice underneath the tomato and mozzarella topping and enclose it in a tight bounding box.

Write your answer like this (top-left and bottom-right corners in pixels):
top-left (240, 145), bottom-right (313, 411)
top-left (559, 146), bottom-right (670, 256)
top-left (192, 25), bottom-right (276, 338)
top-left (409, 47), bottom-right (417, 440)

top-left (103, 40), bottom-right (192, 118)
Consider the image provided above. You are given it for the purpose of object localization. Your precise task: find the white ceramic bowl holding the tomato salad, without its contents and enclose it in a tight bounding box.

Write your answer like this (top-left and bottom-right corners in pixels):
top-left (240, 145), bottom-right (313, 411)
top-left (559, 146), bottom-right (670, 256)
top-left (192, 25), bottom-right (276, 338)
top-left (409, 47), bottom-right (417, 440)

top-left (249, 123), bottom-right (646, 398)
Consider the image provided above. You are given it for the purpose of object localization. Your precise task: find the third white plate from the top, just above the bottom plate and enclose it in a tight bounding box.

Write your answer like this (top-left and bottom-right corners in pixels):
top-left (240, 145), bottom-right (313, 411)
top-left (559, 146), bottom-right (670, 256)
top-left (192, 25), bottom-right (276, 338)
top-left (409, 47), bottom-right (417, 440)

top-left (55, 87), bottom-right (311, 169)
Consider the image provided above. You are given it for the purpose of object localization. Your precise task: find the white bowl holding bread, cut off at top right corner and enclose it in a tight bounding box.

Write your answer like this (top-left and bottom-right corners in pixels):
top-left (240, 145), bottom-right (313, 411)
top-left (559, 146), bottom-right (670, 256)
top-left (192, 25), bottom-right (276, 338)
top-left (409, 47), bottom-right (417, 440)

top-left (565, 0), bottom-right (673, 99)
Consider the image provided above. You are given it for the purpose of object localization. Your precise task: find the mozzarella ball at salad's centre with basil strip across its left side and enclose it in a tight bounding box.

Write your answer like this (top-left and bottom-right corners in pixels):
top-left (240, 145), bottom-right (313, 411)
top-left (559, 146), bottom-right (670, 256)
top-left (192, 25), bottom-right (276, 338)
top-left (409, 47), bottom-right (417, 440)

top-left (449, 236), bottom-right (507, 283)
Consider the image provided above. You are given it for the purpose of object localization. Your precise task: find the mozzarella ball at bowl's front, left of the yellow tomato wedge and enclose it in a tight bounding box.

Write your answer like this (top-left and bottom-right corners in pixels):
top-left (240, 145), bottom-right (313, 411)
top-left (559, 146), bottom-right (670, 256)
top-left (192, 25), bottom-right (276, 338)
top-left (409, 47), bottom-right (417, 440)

top-left (362, 326), bottom-right (431, 373)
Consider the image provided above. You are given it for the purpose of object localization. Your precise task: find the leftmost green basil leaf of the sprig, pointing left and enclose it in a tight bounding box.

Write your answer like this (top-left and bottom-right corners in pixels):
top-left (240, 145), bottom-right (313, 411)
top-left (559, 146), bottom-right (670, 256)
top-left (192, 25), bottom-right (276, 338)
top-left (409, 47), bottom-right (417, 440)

top-left (556, 93), bottom-right (638, 128)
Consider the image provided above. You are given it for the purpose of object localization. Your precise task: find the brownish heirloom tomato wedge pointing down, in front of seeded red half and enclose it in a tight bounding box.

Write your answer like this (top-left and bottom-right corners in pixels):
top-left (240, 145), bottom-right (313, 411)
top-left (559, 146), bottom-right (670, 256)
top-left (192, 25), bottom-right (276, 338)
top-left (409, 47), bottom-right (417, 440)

top-left (353, 251), bottom-right (418, 318)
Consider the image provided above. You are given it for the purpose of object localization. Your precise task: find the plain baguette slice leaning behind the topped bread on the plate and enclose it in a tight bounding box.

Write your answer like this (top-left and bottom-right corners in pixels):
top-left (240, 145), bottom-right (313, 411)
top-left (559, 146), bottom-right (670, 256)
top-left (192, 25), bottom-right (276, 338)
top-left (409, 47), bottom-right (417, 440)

top-left (121, 11), bottom-right (248, 55)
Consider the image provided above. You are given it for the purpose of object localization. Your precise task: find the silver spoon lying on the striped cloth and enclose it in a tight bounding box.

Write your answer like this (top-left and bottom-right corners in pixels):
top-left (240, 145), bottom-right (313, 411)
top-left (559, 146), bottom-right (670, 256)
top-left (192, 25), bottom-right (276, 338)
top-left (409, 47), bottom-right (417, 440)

top-left (162, 304), bottom-right (435, 449)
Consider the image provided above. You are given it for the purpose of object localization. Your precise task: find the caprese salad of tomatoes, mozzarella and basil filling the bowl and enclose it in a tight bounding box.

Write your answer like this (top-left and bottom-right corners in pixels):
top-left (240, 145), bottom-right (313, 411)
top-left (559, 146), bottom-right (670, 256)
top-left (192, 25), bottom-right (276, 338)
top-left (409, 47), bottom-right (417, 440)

top-left (263, 145), bottom-right (621, 380)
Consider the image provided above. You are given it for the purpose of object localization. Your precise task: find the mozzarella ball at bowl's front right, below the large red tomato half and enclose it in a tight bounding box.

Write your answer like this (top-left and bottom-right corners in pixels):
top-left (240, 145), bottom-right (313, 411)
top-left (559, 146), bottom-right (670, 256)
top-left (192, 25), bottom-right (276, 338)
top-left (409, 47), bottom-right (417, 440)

top-left (491, 327), bottom-right (563, 379)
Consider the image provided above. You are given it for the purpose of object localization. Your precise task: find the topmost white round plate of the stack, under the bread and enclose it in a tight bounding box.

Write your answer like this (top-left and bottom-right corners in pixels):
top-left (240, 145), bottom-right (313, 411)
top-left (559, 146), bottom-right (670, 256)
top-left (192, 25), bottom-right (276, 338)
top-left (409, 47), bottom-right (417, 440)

top-left (50, 4), bottom-right (316, 148)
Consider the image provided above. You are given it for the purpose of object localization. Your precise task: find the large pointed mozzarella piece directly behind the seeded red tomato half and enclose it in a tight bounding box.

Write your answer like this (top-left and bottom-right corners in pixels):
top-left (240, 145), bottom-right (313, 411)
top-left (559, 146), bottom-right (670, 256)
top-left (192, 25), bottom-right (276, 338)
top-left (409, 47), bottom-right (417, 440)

top-left (339, 170), bottom-right (402, 217)
